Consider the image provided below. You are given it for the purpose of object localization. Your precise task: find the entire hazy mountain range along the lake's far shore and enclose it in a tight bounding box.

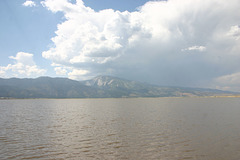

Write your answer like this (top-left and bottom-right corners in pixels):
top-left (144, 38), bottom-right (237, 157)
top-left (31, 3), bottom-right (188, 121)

top-left (0, 76), bottom-right (234, 98)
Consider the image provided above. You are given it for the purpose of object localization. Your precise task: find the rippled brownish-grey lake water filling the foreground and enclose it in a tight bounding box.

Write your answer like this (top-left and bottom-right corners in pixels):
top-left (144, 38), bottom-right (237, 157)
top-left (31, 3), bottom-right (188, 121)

top-left (0, 98), bottom-right (240, 160)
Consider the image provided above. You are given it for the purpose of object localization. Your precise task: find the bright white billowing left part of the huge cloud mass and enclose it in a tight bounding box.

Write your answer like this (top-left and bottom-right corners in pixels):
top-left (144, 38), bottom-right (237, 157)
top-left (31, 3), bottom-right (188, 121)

top-left (42, 0), bottom-right (153, 64)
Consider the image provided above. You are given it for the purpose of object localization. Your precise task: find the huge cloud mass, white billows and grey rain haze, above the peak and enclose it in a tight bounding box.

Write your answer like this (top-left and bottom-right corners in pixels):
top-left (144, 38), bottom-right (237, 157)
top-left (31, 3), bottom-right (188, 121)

top-left (42, 0), bottom-right (240, 90)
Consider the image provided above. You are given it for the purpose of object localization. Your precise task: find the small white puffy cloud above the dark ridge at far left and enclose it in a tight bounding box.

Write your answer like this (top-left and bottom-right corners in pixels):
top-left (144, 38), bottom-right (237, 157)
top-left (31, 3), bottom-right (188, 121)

top-left (0, 52), bottom-right (46, 78)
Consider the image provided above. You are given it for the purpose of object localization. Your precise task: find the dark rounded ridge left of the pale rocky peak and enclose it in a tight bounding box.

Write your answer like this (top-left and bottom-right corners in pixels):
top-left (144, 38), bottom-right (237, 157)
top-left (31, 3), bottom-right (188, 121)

top-left (0, 77), bottom-right (101, 98)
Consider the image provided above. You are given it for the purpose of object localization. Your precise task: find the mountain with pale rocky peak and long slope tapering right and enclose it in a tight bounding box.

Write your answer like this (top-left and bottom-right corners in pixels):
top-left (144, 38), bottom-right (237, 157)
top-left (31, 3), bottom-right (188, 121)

top-left (82, 76), bottom-right (233, 97)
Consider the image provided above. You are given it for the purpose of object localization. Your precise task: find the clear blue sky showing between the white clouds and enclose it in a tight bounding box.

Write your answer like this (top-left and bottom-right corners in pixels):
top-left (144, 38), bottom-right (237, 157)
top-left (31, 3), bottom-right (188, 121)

top-left (0, 0), bottom-right (150, 77)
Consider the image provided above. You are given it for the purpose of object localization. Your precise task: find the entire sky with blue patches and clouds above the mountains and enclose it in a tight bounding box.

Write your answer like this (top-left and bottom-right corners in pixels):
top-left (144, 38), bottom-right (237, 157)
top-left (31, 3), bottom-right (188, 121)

top-left (0, 0), bottom-right (240, 92)
